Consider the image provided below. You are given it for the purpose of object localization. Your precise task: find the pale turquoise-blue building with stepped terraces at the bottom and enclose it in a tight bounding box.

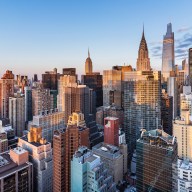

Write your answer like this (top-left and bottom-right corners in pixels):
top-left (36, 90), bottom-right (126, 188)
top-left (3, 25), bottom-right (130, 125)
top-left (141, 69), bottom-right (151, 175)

top-left (71, 146), bottom-right (116, 192)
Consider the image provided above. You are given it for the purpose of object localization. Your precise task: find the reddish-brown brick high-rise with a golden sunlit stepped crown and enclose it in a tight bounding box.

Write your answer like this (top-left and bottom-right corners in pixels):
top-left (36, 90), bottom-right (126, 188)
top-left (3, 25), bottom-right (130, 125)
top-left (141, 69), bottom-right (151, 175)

top-left (53, 113), bottom-right (90, 191)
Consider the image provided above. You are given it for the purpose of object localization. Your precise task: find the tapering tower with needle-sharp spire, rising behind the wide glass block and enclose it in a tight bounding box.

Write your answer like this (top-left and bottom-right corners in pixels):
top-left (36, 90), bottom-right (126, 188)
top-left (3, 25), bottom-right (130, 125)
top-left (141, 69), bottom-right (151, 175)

top-left (137, 27), bottom-right (151, 71)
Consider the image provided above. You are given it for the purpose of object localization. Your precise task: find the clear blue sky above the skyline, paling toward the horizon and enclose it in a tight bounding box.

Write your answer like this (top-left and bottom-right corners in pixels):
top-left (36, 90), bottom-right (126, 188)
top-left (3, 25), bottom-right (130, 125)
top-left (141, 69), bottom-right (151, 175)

top-left (0, 0), bottom-right (192, 76)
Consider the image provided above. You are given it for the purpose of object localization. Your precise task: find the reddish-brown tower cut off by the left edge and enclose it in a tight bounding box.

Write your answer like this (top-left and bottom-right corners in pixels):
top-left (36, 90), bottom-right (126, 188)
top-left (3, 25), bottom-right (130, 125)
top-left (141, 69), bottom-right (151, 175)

top-left (0, 70), bottom-right (14, 118)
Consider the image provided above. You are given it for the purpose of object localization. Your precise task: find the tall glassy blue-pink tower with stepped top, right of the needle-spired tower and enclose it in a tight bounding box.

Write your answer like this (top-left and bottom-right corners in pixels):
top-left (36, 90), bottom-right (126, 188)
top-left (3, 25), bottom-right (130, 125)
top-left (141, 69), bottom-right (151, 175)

top-left (162, 23), bottom-right (175, 81)
